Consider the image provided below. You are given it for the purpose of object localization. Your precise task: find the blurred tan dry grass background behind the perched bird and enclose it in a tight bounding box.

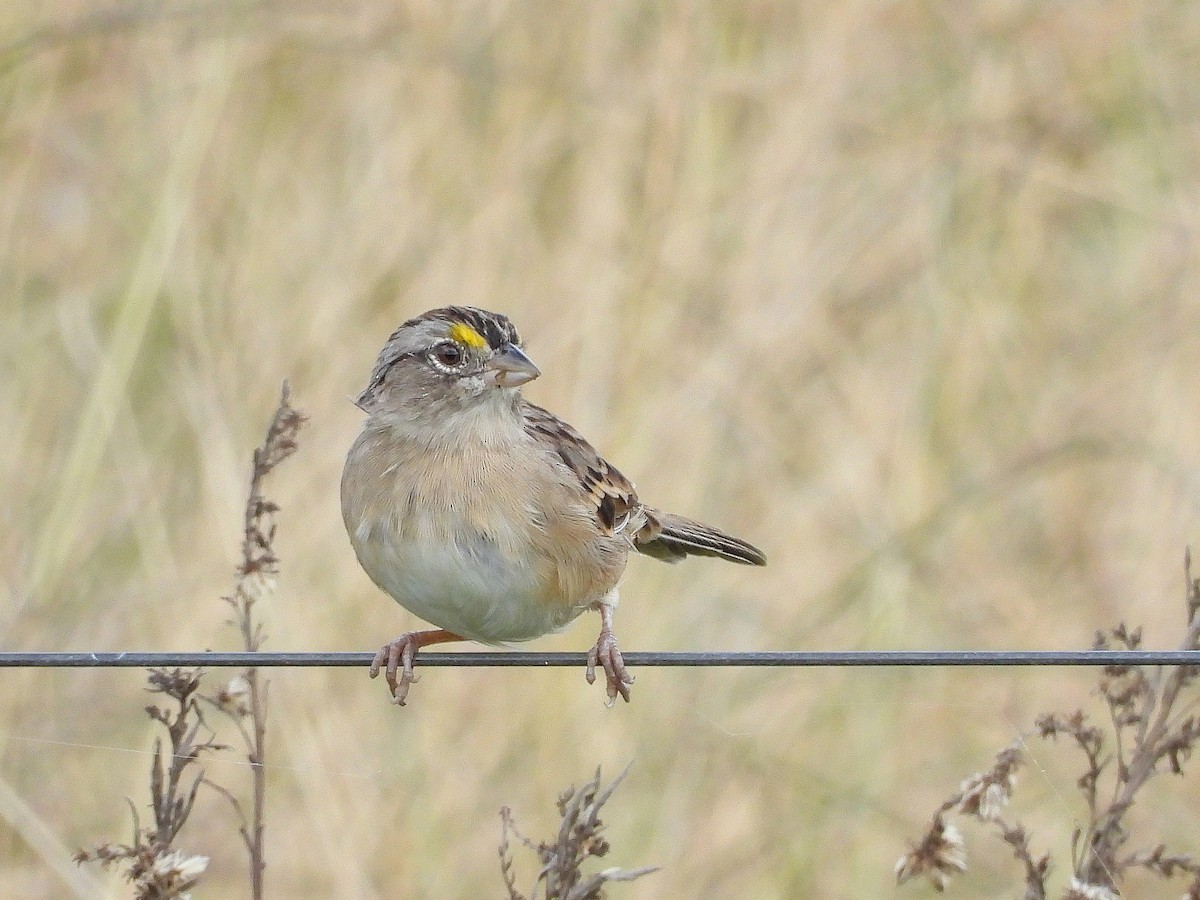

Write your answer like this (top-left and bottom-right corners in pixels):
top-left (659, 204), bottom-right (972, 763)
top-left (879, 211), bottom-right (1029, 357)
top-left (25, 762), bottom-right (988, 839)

top-left (0, 0), bottom-right (1200, 898)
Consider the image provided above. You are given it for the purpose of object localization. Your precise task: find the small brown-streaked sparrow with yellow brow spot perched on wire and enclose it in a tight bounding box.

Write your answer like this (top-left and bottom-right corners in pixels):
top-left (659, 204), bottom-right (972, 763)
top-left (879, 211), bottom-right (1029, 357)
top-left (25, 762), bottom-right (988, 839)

top-left (341, 306), bottom-right (767, 706)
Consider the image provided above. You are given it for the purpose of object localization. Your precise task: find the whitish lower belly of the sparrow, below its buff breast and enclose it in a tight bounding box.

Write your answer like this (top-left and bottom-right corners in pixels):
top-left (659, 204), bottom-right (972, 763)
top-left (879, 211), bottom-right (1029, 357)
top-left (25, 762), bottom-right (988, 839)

top-left (352, 511), bottom-right (586, 643)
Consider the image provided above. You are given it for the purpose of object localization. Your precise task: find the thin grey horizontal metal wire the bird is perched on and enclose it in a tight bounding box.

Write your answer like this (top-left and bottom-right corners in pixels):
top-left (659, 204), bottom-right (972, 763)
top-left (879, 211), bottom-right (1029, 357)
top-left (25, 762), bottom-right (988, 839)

top-left (0, 650), bottom-right (1200, 668)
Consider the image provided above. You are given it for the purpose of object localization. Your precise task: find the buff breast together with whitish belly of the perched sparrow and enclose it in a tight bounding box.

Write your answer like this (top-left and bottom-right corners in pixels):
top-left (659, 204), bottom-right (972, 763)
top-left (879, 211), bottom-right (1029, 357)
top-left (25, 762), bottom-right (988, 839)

top-left (342, 439), bottom-right (609, 643)
